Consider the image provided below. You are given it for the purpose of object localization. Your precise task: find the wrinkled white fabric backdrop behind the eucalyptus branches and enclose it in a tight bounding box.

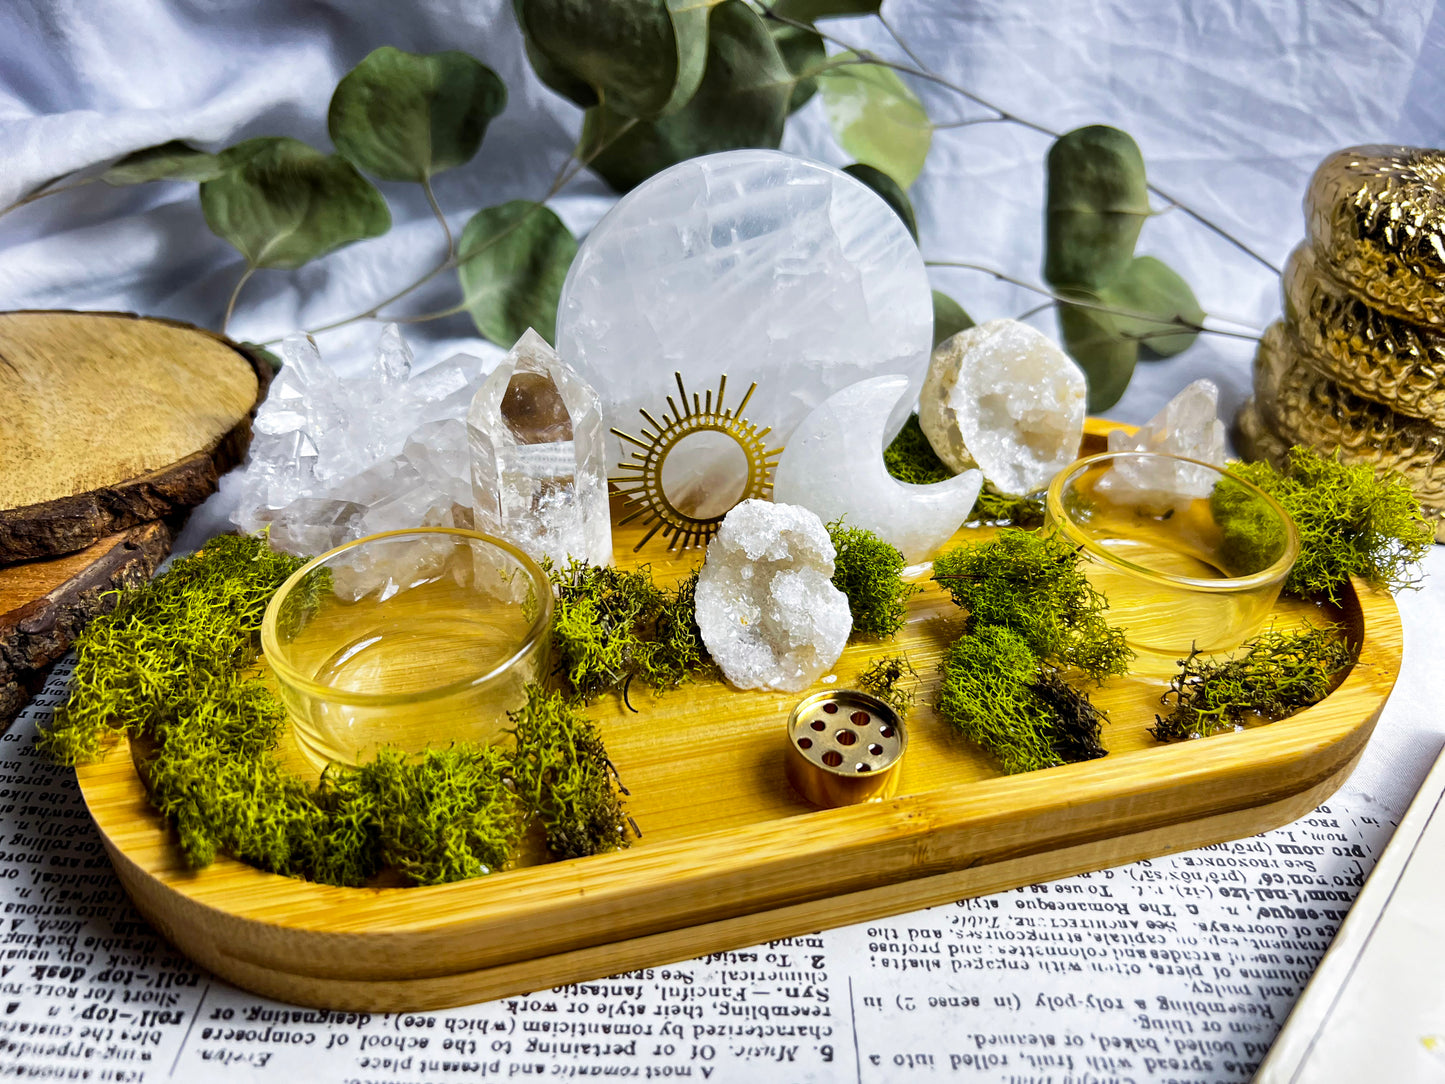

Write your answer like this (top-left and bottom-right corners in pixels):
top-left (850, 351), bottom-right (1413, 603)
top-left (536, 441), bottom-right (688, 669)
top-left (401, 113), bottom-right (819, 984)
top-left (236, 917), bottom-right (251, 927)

top-left (0, 0), bottom-right (1445, 809)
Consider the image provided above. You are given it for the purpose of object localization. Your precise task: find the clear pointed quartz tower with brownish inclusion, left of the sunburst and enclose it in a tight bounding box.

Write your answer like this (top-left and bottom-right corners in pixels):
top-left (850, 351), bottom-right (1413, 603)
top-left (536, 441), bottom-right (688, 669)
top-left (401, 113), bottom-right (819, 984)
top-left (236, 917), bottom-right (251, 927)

top-left (467, 328), bottom-right (613, 567)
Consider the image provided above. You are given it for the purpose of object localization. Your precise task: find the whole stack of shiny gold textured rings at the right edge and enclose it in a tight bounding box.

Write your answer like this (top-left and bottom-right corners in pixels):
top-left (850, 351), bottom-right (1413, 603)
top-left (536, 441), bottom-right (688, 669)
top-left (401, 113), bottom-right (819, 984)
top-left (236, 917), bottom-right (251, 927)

top-left (1237, 146), bottom-right (1445, 542)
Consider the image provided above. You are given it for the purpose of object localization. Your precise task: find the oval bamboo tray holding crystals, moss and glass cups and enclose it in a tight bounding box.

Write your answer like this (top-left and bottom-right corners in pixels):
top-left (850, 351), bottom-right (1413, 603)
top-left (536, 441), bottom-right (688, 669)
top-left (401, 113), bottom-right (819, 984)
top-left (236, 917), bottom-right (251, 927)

top-left (77, 423), bottom-right (1402, 1012)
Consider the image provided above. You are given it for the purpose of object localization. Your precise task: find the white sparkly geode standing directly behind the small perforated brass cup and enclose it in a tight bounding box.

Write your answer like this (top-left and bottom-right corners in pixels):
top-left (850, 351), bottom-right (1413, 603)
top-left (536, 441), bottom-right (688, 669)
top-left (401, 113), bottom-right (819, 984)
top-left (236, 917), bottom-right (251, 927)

top-left (696, 500), bottom-right (853, 692)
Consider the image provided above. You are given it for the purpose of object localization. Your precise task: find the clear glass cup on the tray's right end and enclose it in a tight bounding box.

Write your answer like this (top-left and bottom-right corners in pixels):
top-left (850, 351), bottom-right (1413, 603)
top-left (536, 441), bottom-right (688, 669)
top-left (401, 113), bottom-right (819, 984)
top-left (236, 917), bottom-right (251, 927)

top-left (1045, 451), bottom-right (1299, 675)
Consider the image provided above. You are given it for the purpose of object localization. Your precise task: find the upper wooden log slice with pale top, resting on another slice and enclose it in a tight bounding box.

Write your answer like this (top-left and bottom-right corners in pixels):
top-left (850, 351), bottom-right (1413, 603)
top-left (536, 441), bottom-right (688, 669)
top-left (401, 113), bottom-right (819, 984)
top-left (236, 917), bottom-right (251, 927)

top-left (0, 312), bottom-right (270, 564)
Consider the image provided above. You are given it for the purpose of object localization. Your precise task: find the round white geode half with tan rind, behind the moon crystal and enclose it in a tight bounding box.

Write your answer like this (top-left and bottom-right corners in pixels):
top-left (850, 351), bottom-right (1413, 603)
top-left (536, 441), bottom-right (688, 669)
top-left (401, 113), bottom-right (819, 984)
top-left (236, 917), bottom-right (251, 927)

top-left (918, 319), bottom-right (1087, 494)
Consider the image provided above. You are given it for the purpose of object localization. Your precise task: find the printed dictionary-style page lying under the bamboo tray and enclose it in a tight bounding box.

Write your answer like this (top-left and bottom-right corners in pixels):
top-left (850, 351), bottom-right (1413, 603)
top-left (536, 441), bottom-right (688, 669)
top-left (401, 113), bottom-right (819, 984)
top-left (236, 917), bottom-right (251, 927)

top-left (0, 665), bottom-right (1393, 1084)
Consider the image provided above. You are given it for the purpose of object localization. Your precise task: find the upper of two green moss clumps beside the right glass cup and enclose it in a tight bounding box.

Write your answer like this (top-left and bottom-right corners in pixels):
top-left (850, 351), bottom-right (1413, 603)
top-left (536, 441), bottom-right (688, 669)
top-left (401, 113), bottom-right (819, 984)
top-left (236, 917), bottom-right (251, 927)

top-left (933, 528), bottom-right (1133, 682)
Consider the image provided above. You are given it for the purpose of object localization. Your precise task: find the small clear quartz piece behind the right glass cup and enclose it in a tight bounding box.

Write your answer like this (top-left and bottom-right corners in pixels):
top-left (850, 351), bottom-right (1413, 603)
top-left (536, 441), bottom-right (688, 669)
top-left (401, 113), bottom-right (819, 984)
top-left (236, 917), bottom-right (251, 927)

top-left (1100, 380), bottom-right (1224, 510)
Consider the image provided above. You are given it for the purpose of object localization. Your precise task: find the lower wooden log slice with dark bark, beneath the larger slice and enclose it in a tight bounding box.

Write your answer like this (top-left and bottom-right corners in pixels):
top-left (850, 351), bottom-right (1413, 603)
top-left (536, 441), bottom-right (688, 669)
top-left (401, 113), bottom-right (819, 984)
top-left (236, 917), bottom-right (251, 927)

top-left (0, 523), bottom-right (172, 728)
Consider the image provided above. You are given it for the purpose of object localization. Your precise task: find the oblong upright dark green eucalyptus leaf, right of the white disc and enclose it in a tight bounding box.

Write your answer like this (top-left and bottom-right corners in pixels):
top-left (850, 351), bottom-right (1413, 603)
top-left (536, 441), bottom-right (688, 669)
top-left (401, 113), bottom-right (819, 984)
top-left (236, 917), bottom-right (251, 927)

top-left (1043, 124), bottom-right (1149, 291)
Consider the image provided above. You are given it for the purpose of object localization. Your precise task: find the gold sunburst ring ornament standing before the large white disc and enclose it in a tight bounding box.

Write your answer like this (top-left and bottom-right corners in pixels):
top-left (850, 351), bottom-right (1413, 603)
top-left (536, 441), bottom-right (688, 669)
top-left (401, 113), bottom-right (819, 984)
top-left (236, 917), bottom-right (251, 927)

top-left (613, 373), bottom-right (783, 552)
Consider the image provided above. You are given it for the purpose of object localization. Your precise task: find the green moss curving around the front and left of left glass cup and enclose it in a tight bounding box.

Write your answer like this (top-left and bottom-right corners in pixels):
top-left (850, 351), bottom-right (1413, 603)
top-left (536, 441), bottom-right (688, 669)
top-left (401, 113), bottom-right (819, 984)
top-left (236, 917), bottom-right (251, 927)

top-left (42, 536), bottom-right (620, 885)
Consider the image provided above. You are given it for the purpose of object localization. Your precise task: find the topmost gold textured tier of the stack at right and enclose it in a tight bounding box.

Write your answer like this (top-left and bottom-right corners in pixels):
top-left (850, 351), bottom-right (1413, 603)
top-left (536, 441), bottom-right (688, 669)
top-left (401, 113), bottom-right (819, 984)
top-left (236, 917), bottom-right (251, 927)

top-left (1305, 145), bottom-right (1445, 325)
